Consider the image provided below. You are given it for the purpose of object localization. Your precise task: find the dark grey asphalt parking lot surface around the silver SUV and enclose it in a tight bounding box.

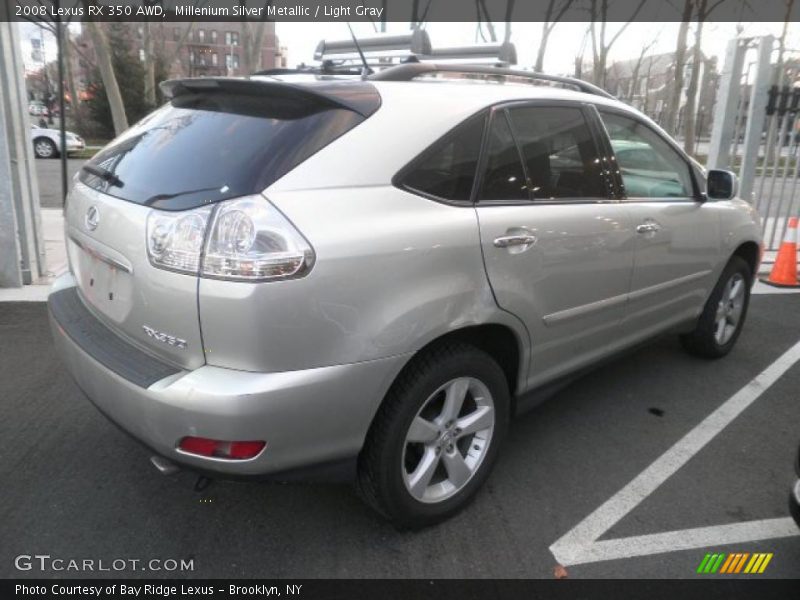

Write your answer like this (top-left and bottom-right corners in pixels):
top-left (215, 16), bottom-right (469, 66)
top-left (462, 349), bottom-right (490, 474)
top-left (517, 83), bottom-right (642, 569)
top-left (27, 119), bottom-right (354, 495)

top-left (0, 295), bottom-right (800, 578)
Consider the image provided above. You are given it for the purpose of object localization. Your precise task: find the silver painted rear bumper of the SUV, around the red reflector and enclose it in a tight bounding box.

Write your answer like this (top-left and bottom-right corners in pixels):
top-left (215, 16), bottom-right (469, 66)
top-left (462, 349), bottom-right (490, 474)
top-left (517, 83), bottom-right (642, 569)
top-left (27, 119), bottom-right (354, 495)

top-left (49, 274), bottom-right (406, 476)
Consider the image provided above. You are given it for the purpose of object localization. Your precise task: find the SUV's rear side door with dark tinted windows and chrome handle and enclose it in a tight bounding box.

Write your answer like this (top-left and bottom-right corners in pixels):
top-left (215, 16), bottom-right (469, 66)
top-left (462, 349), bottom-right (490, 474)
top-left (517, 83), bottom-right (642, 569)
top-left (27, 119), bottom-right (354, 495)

top-left (476, 103), bottom-right (634, 387)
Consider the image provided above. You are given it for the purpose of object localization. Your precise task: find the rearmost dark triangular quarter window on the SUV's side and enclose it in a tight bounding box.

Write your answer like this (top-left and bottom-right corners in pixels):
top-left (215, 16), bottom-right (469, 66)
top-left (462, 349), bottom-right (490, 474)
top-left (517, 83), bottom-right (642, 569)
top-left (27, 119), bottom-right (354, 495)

top-left (400, 114), bottom-right (486, 202)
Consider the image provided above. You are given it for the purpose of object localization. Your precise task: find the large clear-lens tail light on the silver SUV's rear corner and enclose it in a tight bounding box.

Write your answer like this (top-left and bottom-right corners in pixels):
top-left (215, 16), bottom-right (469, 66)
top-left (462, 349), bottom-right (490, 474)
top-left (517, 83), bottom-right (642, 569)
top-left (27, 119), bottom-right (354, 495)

top-left (147, 196), bottom-right (315, 282)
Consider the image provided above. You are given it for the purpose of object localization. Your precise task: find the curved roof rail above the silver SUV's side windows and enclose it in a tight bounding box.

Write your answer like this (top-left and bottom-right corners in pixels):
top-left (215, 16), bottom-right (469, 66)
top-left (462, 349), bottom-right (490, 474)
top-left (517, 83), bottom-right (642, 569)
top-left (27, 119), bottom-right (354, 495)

top-left (367, 62), bottom-right (614, 99)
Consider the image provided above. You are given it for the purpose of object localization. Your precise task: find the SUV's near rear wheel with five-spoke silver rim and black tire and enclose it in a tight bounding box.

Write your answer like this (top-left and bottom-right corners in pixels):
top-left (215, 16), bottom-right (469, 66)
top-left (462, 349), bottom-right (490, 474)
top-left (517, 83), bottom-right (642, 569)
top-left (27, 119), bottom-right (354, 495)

top-left (357, 343), bottom-right (510, 529)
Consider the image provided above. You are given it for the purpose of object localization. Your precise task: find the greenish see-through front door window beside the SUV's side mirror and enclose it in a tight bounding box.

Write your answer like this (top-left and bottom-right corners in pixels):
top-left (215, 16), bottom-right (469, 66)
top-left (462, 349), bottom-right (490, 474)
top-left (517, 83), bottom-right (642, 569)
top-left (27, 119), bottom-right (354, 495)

top-left (600, 111), bottom-right (694, 198)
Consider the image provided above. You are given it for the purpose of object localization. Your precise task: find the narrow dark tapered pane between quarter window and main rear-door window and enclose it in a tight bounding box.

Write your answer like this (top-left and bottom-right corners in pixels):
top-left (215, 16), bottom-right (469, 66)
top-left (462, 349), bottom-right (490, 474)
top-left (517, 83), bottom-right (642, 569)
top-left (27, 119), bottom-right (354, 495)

top-left (479, 111), bottom-right (530, 200)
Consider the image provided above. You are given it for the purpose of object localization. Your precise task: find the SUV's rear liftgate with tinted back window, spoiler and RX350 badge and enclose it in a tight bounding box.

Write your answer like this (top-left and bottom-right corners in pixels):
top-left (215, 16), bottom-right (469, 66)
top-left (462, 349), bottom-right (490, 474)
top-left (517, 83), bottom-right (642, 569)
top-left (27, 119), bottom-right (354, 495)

top-left (66, 79), bottom-right (379, 369)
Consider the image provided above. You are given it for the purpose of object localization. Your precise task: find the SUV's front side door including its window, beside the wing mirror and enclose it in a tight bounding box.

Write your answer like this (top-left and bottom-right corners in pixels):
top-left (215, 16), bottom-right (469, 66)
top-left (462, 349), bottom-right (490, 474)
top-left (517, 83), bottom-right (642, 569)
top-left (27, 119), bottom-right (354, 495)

top-left (600, 109), bottom-right (721, 341)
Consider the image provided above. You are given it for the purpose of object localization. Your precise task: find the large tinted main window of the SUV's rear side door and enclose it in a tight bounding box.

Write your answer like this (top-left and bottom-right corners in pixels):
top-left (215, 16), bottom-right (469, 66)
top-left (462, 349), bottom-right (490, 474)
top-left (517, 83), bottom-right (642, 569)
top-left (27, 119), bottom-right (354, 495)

top-left (508, 106), bottom-right (606, 200)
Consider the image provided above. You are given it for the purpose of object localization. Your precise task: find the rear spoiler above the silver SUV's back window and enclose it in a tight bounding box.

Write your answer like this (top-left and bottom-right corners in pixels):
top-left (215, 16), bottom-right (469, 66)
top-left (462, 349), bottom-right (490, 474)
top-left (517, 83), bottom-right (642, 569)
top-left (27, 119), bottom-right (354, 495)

top-left (159, 77), bottom-right (381, 118)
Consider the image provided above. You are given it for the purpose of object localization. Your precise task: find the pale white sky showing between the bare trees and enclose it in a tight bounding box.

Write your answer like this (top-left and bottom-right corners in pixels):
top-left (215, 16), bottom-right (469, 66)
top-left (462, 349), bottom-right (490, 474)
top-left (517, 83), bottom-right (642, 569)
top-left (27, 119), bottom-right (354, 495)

top-left (20, 22), bottom-right (800, 74)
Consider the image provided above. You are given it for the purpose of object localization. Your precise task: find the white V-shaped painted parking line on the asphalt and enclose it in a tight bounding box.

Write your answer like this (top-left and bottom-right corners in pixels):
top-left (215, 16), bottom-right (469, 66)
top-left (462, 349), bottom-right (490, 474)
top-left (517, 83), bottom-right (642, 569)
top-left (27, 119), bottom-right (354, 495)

top-left (550, 342), bottom-right (800, 566)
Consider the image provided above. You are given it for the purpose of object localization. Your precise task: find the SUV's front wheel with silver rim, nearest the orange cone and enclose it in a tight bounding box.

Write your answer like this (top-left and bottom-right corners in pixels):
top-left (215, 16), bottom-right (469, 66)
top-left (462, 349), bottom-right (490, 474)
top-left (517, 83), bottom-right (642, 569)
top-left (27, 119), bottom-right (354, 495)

top-left (680, 256), bottom-right (753, 358)
